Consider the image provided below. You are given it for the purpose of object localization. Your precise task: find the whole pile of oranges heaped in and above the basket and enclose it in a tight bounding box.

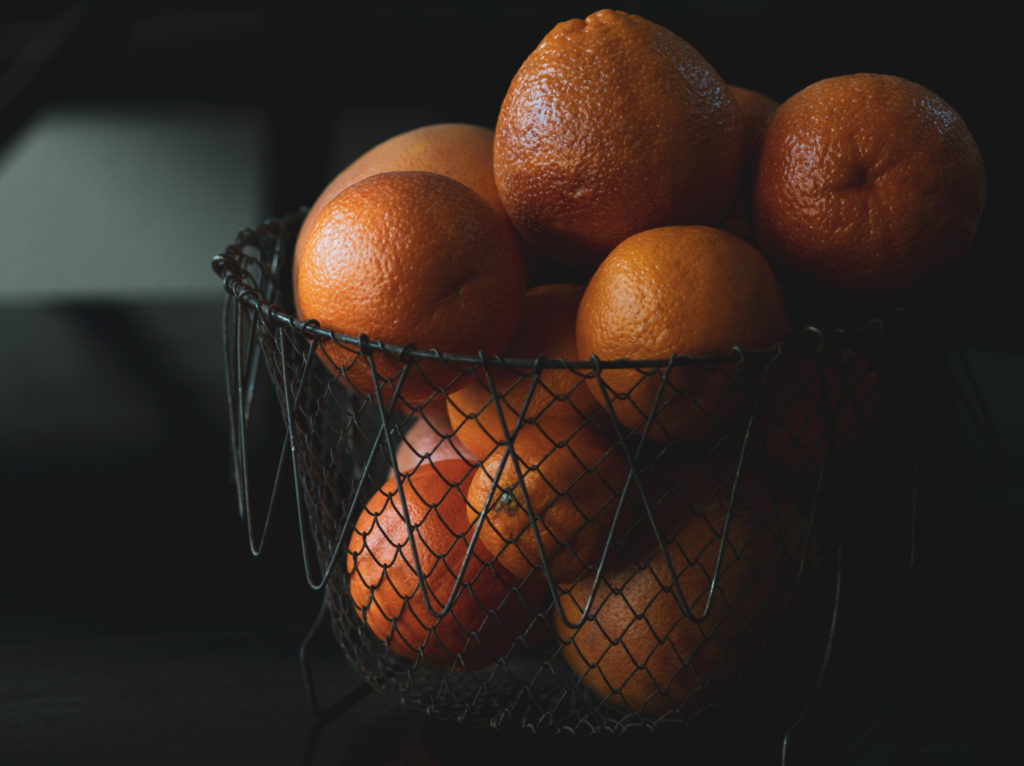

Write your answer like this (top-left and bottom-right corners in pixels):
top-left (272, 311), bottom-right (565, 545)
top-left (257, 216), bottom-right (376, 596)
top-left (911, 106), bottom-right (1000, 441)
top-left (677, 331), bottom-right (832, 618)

top-left (293, 10), bottom-right (985, 716)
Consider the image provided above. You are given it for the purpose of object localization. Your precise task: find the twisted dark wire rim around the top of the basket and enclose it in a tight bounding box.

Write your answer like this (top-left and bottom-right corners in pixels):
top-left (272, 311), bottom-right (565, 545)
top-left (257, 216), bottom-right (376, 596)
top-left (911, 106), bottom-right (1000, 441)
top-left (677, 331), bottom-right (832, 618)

top-left (211, 207), bottom-right (908, 372)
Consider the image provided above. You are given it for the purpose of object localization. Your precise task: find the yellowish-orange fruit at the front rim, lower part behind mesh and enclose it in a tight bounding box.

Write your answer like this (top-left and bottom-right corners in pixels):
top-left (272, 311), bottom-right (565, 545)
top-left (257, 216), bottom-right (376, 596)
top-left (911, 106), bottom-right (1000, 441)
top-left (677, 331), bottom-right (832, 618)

top-left (577, 226), bottom-right (787, 441)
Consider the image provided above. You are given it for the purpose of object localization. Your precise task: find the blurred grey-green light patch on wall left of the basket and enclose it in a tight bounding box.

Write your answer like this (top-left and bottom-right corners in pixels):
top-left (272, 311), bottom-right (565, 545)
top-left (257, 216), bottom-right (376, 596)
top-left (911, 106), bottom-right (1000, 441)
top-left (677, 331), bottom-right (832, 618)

top-left (0, 103), bottom-right (269, 301)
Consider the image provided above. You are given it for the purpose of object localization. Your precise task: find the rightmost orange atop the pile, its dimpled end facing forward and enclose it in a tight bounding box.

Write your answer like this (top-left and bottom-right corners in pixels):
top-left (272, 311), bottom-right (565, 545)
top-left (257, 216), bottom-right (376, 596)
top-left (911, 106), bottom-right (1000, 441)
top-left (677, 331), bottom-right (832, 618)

top-left (752, 74), bottom-right (985, 295)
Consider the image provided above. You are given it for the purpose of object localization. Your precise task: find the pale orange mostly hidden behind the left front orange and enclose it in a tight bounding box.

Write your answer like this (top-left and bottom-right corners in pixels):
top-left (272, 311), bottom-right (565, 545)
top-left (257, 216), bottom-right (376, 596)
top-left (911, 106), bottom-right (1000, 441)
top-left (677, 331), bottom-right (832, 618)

top-left (293, 123), bottom-right (540, 286)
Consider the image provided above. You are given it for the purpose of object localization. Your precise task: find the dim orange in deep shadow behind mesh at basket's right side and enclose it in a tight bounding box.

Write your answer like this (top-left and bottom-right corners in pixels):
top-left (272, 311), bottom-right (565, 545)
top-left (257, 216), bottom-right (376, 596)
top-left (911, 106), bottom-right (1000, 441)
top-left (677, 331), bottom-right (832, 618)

top-left (752, 348), bottom-right (879, 475)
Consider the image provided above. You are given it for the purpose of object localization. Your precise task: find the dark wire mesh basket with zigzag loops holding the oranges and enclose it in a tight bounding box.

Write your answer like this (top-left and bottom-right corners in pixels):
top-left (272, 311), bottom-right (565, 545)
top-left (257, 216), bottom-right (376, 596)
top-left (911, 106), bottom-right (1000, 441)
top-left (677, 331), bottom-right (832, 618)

top-left (214, 211), bottom-right (917, 734)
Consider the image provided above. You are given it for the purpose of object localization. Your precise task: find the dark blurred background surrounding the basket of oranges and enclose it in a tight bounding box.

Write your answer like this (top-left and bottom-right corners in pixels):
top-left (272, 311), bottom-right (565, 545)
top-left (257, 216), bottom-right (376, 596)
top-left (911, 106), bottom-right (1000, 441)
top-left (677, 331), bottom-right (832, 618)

top-left (0, 0), bottom-right (1024, 766)
